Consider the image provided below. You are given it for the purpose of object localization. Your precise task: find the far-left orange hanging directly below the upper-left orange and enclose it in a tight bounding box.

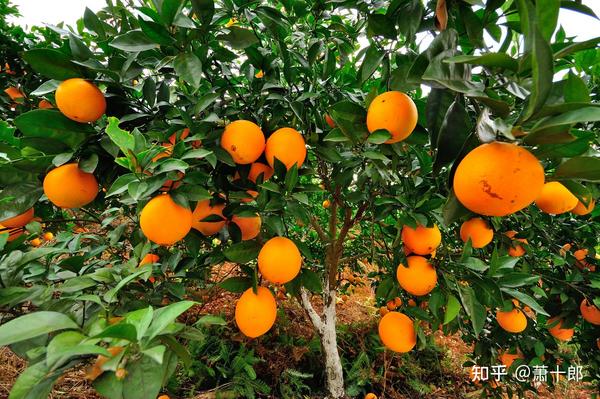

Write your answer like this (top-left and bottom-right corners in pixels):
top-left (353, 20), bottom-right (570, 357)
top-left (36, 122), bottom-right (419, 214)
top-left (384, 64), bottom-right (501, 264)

top-left (44, 163), bottom-right (98, 209)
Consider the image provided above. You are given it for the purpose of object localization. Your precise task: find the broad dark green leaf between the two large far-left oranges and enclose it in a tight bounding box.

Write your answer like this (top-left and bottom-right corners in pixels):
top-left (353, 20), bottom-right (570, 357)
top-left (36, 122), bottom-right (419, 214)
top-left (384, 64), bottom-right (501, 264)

top-left (15, 109), bottom-right (95, 149)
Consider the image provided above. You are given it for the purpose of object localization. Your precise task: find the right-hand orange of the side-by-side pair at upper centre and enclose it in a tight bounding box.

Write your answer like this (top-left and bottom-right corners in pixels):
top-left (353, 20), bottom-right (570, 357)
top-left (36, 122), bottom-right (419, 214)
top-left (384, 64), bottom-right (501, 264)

top-left (265, 127), bottom-right (306, 170)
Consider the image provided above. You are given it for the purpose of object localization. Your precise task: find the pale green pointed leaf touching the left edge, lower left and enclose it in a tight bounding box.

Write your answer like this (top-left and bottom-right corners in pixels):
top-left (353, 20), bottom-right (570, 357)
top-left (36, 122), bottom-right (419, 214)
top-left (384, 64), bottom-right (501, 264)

top-left (0, 311), bottom-right (79, 346)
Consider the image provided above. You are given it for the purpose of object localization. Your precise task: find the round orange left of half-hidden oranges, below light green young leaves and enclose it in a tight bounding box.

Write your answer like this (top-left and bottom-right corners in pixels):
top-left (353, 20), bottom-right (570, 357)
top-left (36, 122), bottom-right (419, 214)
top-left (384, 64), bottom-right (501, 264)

top-left (140, 194), bottom-right (192, 245)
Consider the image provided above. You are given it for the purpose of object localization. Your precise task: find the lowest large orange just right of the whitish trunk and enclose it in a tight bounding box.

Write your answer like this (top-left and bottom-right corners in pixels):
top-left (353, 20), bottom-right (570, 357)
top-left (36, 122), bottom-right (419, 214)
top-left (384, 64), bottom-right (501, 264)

top-left (378, 312), bottom-right (417, 353)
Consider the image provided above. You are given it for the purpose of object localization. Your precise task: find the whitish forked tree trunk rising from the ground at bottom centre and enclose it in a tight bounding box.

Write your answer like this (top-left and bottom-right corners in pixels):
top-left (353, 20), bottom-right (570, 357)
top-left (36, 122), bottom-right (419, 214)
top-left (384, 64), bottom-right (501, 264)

top-left (300, 283), bottom-right (345, 399)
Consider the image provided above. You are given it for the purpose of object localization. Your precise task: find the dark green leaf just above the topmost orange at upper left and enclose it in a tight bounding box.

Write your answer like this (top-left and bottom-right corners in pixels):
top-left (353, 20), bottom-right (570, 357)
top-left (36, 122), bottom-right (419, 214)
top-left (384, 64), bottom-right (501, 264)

top-left (22, 48), bottom-right (83, 80)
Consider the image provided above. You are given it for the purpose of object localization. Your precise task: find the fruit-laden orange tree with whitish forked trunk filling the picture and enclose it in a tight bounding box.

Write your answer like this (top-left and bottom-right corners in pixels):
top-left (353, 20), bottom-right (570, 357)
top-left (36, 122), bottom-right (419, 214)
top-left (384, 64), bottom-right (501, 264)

top-left (0, 0), bottom-right (600, 398)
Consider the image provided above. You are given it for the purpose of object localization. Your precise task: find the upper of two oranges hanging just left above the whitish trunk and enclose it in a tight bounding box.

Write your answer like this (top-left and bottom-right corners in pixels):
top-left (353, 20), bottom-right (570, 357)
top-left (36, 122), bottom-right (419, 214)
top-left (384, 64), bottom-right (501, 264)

top-left (258, 237), bottom-right (302, 284)
